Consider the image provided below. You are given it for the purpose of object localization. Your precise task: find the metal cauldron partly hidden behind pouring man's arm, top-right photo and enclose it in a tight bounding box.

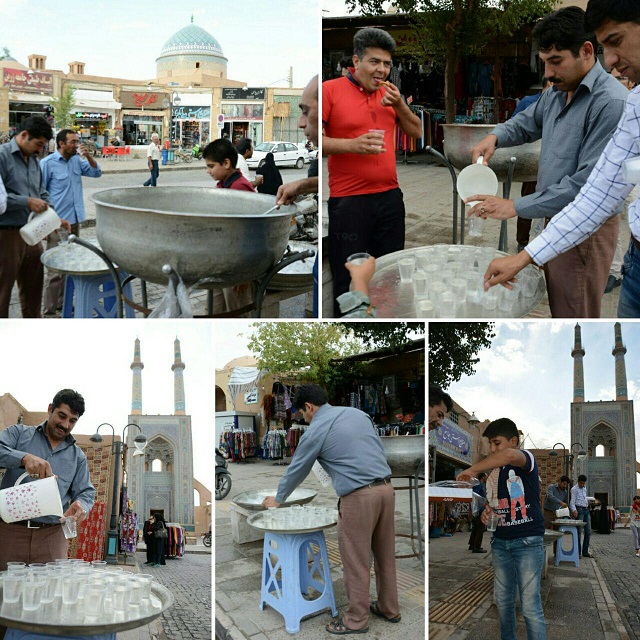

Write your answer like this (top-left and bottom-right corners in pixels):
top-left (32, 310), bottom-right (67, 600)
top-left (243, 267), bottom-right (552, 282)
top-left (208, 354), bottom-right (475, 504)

top-left (443, 124), bottom-right (542, 182)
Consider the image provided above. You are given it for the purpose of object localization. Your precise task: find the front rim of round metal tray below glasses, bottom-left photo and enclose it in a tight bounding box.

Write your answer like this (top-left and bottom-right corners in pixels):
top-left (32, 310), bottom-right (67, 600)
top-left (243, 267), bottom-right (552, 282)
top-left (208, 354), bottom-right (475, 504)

top-left (0, 582), bottom-right (174, 637)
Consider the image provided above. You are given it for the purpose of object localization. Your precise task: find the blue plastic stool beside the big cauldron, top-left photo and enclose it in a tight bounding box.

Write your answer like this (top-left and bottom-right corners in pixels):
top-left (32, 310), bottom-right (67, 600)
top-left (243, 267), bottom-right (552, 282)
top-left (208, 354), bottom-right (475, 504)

top-left (62, 269), bottom-right (135, 318)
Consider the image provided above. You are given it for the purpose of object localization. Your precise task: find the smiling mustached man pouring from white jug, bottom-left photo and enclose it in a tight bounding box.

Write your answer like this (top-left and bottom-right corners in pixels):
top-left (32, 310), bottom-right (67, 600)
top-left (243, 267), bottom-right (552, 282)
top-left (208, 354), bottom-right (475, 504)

top-left (0, 389), bottom-right (96, 570)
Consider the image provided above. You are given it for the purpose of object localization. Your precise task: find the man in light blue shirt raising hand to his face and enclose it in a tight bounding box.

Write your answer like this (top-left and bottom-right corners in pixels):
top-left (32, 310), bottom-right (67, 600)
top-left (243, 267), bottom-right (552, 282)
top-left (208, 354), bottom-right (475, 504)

top-left (40, 129), bottom-right (102, 315)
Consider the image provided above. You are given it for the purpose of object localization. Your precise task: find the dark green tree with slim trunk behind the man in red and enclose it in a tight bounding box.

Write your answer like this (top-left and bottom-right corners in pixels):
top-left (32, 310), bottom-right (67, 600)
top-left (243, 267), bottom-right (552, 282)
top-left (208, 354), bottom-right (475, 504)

top-left (346, 0), bottom-right (557, 123)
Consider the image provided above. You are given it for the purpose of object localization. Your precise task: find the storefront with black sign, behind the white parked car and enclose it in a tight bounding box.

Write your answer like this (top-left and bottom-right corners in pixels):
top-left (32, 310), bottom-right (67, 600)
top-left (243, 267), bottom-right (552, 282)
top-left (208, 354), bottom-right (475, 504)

top-left (221, 88), bottom-right (266, 146)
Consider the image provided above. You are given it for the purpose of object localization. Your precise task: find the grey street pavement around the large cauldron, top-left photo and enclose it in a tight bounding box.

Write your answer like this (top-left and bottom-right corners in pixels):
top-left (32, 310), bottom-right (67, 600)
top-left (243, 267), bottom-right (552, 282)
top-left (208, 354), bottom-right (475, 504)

top-left (9, 158), bottom-right (312, 318)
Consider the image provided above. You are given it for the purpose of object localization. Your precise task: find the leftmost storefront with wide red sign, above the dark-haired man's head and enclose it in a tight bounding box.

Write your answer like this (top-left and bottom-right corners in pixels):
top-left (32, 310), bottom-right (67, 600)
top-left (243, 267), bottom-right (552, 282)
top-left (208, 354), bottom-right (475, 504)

top-left (3, 68), bottom-right (53, 132)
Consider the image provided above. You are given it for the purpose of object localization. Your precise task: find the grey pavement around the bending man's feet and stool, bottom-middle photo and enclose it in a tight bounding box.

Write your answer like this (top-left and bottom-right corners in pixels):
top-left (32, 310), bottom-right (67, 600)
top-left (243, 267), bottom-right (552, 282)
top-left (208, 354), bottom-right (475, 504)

top-left (214, 459), bottom-right (425, 640)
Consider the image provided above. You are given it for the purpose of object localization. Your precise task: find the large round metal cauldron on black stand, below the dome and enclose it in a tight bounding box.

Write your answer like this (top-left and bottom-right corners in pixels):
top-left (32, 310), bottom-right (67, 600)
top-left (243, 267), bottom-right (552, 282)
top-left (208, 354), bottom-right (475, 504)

top-left (92, 187), bottom-right (298, 287)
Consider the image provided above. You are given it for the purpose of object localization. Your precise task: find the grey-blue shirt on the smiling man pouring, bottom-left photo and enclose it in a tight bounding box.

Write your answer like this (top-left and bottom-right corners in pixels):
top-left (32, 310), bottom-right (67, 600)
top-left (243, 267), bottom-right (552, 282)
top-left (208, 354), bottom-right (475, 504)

top-left (0, 422), bottom-right (96, 522)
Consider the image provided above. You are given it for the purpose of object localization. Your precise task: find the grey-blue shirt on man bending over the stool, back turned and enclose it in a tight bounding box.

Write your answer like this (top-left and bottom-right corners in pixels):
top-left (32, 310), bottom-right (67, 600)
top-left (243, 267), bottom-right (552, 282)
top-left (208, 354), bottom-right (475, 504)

top-left (276, 404), bottom-right (391, 503)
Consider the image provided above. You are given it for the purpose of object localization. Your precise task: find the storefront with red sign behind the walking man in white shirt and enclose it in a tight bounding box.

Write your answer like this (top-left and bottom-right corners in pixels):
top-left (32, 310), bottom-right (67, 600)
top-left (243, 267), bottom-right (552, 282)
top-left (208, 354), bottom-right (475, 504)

top-left (120, 91), bottom-right (168, 145)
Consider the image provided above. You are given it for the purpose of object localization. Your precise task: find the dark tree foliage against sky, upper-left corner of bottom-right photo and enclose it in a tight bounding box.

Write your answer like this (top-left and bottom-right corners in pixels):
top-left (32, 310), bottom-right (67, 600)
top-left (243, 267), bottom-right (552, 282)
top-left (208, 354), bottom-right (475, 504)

top-left (428, 322), bottom-right (496, 389)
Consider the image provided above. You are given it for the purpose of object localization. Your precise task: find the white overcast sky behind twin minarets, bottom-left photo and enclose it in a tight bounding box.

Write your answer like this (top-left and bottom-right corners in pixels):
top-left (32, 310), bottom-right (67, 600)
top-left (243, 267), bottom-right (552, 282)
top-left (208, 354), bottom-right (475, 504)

top-left (0, 320), bottom-right (215, 492)
